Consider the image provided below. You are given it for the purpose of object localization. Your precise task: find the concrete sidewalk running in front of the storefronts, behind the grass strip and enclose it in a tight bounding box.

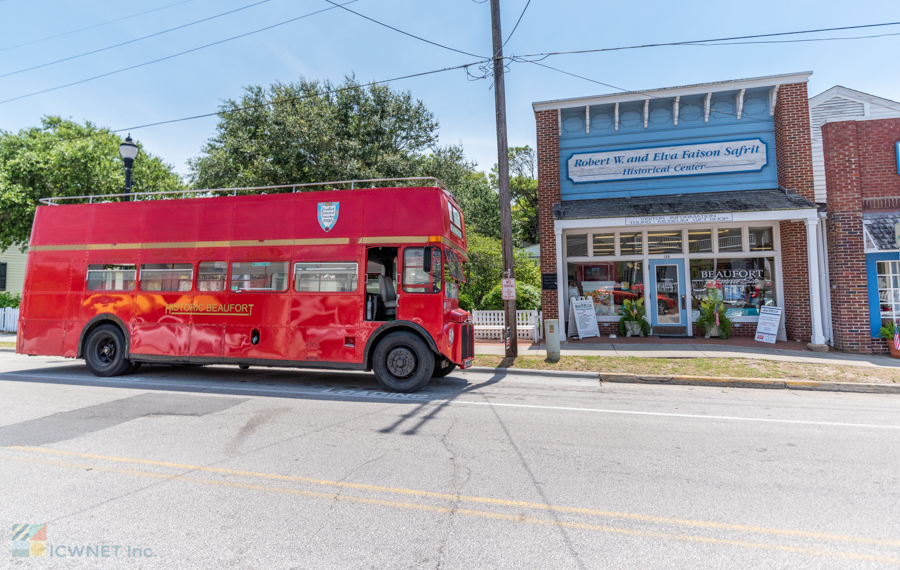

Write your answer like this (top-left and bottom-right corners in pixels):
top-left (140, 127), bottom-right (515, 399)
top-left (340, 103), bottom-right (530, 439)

top-left (475, 342), bottom-right (900, 368)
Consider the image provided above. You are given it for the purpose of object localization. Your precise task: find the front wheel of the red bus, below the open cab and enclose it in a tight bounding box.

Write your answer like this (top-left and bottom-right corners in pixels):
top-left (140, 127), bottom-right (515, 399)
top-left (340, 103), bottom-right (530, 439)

top-left (372, 331), bottom-right (434, 392)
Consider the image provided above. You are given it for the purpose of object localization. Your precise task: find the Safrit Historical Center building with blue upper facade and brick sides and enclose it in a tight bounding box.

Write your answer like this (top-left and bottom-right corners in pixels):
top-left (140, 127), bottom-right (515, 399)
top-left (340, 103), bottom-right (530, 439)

top-left (533, 73), bottom-right (828, 347)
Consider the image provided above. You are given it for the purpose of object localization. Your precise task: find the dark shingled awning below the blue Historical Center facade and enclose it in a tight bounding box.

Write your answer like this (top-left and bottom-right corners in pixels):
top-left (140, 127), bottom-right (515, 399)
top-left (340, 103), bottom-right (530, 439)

top-left (553, 188), bottom-right (820, 220)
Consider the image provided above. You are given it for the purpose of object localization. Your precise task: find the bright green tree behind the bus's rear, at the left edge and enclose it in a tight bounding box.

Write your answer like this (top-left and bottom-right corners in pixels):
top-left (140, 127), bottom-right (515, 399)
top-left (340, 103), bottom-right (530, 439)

top-left (0, 116), bottom-right (184, 251)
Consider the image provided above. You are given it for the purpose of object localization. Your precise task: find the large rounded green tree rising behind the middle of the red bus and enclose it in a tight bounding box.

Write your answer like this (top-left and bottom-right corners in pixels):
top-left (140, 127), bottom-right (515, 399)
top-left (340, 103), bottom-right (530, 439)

top-left (189, 77), bottom-right (450, 188)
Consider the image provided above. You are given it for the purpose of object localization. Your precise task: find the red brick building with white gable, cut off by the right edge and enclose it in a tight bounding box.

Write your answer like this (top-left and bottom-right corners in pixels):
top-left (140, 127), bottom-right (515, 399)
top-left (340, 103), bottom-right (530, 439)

top-left (828, 93), bottom-right (900, 353)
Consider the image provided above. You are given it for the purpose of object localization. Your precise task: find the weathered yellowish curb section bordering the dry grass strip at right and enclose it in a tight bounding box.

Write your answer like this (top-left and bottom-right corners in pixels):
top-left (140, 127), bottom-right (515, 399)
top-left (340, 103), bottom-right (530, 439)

top-left (600, 372), bottom-right (900, 394)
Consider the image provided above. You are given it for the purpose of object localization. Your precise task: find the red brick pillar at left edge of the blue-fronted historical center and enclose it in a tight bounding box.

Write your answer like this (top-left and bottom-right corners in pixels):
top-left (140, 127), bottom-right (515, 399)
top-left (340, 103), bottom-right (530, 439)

top-left (535, 110), bottom-right (566, 320)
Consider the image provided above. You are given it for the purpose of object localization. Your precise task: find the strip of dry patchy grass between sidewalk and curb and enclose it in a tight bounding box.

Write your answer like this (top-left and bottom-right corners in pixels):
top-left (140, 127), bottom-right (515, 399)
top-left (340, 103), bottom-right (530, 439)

top-left (475, 355), bottom-right (900, 383)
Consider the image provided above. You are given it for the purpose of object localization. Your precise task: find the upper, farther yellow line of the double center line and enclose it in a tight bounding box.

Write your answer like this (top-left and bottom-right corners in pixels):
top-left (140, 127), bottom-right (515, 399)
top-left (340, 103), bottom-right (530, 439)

top-left (7, 446), bottom-right (900, 547)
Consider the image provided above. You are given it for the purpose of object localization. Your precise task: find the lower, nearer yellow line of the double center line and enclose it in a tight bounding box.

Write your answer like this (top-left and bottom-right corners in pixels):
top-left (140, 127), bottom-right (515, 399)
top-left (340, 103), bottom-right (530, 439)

top-left (0, 447), bottom-right (900, 565)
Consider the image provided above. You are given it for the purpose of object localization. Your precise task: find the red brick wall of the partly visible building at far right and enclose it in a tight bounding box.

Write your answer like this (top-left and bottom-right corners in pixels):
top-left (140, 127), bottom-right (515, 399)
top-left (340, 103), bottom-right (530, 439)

top-left (822, 119), bottom-right (900, 354)
